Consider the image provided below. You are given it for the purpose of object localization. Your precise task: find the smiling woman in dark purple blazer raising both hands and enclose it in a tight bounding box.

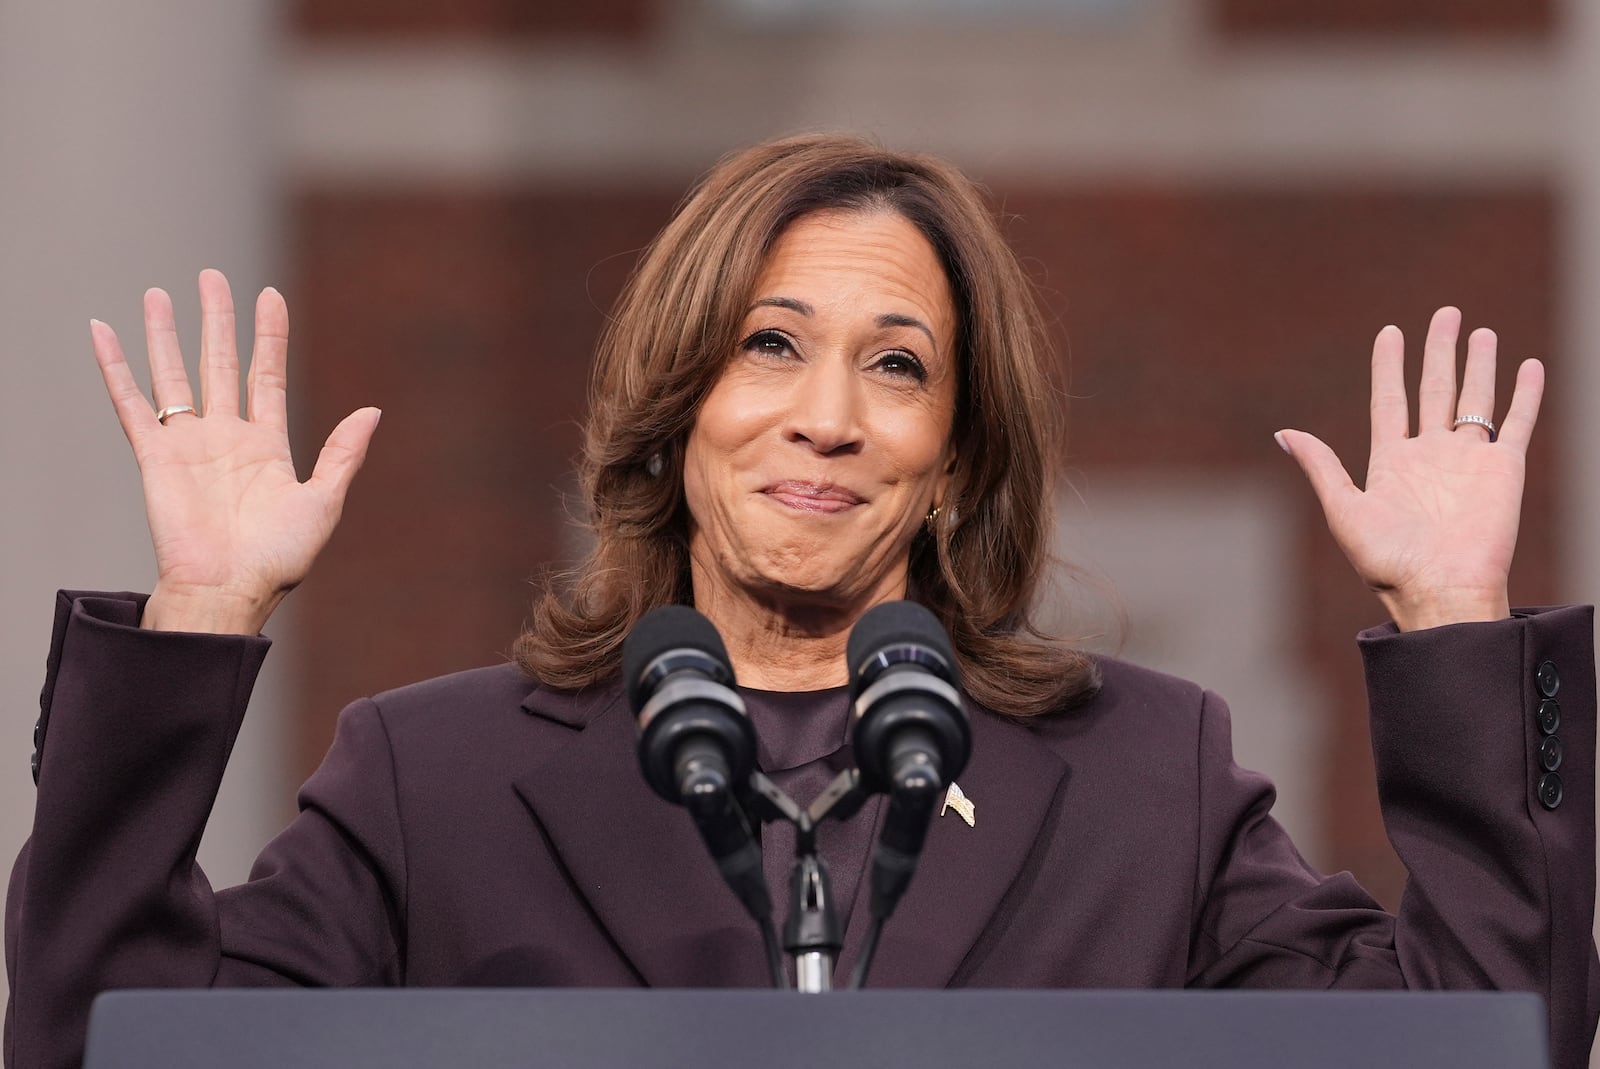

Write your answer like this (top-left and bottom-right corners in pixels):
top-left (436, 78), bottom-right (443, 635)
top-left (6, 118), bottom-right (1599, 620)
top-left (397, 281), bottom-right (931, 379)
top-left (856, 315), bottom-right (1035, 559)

top-left (6, 138), bottom-right (1595, 1066)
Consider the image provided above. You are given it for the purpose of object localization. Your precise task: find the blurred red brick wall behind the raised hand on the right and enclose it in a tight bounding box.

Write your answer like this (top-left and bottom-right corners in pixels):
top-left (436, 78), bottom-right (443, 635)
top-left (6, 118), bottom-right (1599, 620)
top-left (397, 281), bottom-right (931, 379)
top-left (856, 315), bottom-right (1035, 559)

top-left (1005, 189), bottom-right (1563, 904)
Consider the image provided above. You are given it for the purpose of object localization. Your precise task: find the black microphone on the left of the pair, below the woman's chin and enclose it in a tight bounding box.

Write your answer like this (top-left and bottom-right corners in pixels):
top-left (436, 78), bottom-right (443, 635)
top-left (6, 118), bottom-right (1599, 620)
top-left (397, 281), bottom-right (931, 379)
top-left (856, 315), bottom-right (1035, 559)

top-left (622, 605), bottom-right (773, 923)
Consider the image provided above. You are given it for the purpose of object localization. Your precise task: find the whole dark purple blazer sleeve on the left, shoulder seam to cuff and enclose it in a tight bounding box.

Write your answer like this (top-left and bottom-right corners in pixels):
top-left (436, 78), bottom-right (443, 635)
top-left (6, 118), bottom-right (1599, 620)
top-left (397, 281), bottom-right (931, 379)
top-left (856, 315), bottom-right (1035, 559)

top-left (5, 592), bottom-right (403, 1067)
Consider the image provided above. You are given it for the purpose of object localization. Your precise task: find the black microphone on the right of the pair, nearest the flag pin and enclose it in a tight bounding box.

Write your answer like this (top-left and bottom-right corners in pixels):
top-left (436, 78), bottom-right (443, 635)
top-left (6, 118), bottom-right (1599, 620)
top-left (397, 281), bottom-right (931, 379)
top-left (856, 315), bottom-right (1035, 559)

top-left (846, 602), bottom-right (973, 920)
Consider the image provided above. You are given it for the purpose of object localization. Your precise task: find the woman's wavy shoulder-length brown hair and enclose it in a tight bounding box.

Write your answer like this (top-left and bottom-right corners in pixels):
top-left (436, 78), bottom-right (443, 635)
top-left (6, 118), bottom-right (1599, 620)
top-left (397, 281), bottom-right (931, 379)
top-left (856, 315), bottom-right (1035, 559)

top-left (517, 134), bottom-right (1096, 717)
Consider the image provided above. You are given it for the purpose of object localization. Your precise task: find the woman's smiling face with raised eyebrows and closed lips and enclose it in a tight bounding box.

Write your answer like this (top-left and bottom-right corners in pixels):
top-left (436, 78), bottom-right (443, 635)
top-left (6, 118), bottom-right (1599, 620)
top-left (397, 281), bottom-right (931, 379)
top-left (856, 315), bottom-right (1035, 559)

top-left (683, 210), bottom-right (958, 613)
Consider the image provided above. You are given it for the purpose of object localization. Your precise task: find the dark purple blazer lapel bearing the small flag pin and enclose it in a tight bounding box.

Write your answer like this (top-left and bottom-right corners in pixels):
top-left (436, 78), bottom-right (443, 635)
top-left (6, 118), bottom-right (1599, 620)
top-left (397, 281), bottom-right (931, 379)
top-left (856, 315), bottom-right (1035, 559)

top-left (838, 711), bottom-right (1066, 987)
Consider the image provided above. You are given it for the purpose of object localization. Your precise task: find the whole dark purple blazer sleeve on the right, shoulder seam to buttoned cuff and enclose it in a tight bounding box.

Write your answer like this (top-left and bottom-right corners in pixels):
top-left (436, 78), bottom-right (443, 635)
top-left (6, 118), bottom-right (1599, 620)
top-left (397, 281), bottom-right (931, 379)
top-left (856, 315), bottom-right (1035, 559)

top-left (1190, 607), bottom-right (1600, 1069)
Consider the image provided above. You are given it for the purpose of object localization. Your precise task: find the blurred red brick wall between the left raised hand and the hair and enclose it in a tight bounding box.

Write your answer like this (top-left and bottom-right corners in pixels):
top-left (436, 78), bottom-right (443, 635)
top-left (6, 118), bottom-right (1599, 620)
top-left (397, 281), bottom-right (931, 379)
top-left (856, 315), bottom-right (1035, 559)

top-left (291, 194), bottom-right (674, 773)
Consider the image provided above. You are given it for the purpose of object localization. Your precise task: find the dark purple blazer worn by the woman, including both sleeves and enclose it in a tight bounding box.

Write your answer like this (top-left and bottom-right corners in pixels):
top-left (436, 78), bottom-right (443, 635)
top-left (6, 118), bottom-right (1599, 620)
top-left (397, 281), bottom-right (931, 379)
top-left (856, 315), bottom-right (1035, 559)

top-left (5, 595), bottom-right (1600, 1067)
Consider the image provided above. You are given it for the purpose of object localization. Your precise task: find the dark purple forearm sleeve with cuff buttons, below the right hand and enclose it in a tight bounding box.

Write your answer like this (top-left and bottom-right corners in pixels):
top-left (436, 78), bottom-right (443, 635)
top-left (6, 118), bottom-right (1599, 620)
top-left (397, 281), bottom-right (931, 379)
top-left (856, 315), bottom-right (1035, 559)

top-left (1362, 608), bottom-right (1600, 1066)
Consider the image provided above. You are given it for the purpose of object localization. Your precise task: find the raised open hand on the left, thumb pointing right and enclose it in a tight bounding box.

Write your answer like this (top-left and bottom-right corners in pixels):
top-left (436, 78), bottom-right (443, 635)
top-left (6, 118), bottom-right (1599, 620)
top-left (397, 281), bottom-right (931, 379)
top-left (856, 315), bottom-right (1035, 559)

top-left (90, 270), bottom-right (379, 634)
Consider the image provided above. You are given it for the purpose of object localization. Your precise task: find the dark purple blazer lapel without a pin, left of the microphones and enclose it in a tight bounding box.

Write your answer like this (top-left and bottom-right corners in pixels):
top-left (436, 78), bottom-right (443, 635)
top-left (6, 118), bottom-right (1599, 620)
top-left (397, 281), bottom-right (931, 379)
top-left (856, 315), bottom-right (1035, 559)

top-left (514, 685), bottom-right (766, 987)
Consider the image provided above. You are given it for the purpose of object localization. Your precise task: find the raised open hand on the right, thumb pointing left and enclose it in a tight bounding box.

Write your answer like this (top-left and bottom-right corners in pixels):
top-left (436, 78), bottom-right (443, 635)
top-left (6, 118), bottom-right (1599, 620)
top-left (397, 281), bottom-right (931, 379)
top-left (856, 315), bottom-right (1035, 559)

top-left (1278, 307), bottom-right (1544, 631)
